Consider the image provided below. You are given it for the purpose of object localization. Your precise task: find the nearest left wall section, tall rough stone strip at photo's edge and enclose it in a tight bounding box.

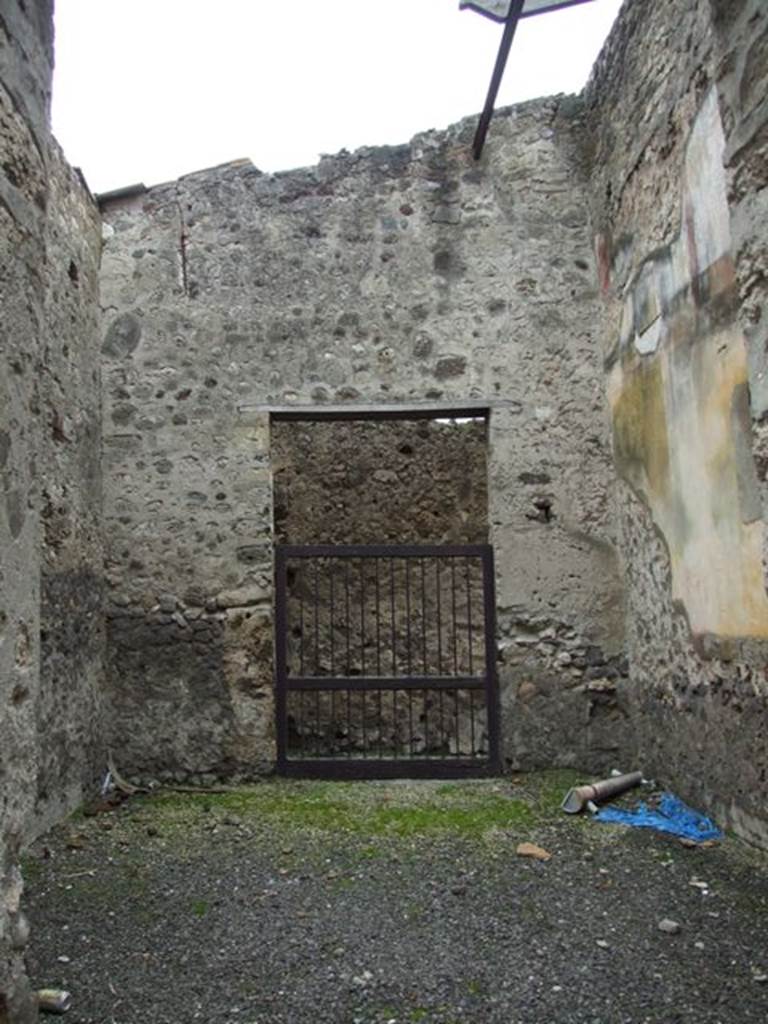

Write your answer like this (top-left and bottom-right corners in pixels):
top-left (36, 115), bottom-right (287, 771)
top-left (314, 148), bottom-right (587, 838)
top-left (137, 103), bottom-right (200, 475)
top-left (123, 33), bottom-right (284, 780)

top-left (0, 3), bottom-right (52, 1024)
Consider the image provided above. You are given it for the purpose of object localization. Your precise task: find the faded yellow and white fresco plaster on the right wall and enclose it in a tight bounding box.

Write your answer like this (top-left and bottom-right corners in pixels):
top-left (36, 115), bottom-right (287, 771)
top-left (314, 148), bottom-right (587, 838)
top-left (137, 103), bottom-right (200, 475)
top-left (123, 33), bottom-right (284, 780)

top-left (608, 89), bottom-right (768, 637)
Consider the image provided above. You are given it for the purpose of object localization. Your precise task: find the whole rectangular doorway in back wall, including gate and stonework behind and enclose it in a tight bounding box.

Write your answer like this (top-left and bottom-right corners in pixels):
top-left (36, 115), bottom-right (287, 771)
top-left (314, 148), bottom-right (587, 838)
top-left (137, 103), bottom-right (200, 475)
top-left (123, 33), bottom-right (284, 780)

top-left (271, 413), bottom-right (499, 777)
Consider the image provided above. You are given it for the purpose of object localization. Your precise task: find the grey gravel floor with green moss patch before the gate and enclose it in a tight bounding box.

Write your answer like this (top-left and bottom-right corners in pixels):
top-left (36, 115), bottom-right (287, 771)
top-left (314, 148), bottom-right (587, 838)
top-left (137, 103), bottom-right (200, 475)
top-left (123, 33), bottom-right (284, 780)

top-left (20, 774), bottom-right (768, 1024)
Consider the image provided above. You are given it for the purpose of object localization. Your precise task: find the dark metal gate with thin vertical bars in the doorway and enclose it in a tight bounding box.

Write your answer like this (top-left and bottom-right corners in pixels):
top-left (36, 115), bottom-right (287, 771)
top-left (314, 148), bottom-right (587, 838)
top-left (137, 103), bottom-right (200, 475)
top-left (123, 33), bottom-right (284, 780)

top-left (275, 545), bottom-right (500, 778)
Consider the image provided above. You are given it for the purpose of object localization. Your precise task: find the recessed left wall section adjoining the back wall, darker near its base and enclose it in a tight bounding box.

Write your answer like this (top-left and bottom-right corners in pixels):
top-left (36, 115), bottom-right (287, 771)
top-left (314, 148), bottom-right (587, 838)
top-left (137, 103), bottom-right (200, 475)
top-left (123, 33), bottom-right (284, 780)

top-left (31, 140), bottom-right (106, 833)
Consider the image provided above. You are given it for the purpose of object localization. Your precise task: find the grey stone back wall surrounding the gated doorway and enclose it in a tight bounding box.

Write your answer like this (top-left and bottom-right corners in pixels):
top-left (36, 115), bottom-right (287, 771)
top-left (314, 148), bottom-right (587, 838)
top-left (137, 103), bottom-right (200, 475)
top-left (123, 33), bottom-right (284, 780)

top-left (101, 97), bottom-right (623, 776)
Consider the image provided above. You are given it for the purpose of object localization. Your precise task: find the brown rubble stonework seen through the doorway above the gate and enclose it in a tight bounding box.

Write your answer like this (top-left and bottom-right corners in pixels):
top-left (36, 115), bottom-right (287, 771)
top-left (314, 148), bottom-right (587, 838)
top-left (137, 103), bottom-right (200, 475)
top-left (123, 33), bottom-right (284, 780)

top-left (271, 419), bottom-right (488, 544)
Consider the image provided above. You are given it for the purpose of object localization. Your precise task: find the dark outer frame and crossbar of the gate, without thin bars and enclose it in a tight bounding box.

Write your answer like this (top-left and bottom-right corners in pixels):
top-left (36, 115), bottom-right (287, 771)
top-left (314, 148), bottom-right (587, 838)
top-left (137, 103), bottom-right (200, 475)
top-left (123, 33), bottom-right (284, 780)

top-left (274, 544), bottom-right (501, 778)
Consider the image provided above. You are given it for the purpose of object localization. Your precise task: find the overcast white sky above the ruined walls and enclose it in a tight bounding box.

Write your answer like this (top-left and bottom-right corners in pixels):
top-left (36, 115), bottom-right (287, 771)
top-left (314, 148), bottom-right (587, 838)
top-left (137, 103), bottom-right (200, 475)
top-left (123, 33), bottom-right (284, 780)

top-left (53, 0), bottom-right (621, 193)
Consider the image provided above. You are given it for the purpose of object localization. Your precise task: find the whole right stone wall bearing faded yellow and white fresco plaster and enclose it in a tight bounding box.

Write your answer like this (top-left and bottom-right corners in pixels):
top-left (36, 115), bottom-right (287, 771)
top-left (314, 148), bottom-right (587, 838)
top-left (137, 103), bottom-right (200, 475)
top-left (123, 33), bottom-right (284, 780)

top-left (586, 0), bottom-right (768, 843)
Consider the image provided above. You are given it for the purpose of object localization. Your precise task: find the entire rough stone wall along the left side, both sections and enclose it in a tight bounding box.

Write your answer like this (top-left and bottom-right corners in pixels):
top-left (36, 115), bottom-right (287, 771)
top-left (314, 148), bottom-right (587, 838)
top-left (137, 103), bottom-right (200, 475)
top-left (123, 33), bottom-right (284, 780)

top-left (0, 0), bottom-right (103, 1011)
